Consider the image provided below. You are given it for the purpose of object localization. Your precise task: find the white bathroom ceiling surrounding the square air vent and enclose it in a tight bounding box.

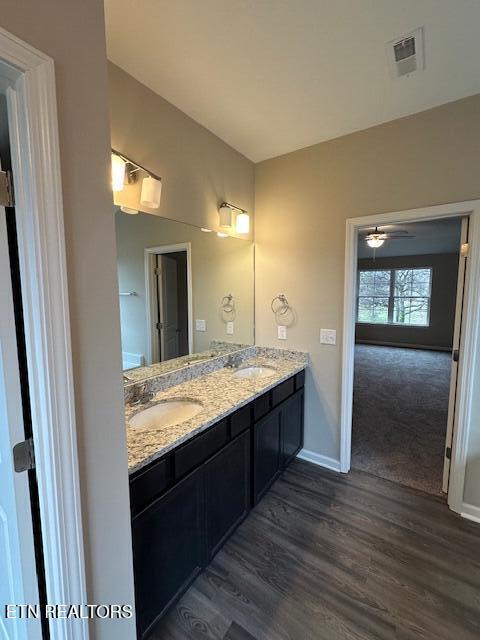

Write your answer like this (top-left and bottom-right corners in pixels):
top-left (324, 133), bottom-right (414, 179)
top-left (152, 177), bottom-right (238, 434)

top-left (105, 0), bottom-right (480, 162)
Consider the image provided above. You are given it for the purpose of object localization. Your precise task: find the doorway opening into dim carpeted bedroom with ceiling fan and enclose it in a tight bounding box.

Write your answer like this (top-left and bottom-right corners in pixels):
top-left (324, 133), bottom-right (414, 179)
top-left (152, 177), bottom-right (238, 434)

top-left (352, 217), bottom-right (468, 495)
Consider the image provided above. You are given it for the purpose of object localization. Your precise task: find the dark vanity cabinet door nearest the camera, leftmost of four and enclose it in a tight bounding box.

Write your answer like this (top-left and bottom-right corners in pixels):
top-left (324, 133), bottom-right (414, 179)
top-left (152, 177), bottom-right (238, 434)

top-left (132, 469), bottom-right (204, 638)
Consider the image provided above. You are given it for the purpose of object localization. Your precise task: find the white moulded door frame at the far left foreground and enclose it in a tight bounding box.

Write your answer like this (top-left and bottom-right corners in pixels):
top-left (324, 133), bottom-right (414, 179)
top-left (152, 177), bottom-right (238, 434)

top-left (0, 29), bottom-right (89, 640)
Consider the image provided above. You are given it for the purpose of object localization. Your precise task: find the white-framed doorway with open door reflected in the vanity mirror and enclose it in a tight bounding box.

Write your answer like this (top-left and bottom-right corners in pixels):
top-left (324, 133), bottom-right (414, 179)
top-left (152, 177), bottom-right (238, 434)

top-left (145, 243), bottom-right (193, 364)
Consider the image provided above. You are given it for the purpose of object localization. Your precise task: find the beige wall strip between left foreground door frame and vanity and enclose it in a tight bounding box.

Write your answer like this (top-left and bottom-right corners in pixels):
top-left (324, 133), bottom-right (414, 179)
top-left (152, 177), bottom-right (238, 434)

top-left (1, 0), bottom-right (135, 640)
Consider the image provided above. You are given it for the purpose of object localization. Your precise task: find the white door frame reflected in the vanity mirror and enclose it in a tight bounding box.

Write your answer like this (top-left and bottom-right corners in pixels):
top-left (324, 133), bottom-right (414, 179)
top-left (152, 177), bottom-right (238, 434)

top-left (145, 242), bottom-right (193, 364)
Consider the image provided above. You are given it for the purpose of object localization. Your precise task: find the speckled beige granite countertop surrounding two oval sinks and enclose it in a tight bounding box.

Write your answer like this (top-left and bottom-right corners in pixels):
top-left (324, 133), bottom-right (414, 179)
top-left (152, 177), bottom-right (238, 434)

top-left (125, 356), bottom-right (307, 473)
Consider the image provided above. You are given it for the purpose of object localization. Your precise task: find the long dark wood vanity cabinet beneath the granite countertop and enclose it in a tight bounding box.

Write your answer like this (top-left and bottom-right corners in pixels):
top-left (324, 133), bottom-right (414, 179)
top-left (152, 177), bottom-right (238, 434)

top-left (130, 372), bottom-right (304, 638)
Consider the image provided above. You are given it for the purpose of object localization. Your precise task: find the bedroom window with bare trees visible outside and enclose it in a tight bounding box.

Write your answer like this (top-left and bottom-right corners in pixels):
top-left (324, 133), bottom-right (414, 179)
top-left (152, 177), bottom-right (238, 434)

top-left (357, 267), bottom-right (432, 326)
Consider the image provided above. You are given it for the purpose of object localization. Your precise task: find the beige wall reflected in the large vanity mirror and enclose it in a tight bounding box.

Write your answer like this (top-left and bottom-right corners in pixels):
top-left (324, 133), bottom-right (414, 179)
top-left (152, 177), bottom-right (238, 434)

top-left (115, 212), bottom-right (254, 357)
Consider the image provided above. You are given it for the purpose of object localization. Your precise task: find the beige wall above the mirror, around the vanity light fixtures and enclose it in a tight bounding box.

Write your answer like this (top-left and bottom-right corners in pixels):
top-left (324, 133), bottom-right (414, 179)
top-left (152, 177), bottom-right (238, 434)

top-left (108, 63), bottom-right (254, 238)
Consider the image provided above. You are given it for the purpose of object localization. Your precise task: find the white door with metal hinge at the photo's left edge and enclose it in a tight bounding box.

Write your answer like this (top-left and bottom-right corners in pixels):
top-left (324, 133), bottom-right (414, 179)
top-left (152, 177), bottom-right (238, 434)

top-left (0, 207), bottom-right (42, 640)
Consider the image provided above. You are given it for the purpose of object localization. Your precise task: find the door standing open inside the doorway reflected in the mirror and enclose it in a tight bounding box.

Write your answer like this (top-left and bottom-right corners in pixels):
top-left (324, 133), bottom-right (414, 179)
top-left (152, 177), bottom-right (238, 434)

top-left (157, 253), bottom-right (180, 360)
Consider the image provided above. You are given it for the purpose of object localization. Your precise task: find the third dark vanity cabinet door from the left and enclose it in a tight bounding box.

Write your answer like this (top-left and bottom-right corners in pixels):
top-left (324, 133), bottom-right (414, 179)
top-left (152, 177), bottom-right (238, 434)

top-left (253, 409), bottom-right (280, 503)
